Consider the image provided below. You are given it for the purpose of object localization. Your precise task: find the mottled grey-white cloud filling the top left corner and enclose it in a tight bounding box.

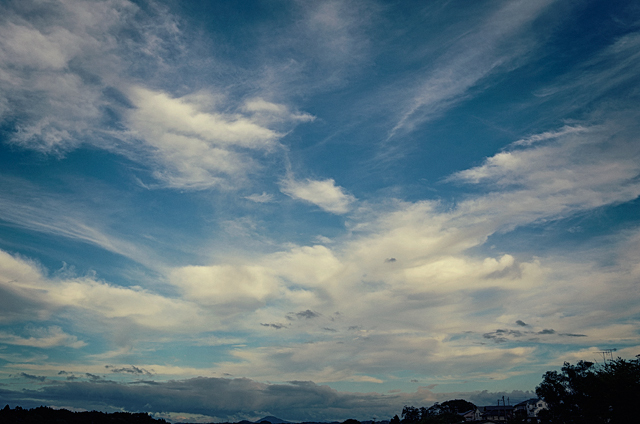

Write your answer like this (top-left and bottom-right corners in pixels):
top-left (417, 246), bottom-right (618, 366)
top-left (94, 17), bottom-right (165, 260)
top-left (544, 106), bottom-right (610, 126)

top-left (0, 0), bottom-right (137, 153)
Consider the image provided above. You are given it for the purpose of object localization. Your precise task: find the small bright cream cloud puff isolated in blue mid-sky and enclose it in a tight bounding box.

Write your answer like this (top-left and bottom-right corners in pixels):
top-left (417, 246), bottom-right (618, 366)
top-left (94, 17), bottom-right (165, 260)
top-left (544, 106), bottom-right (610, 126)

top-left (280, 178), bottom-right (356, 214)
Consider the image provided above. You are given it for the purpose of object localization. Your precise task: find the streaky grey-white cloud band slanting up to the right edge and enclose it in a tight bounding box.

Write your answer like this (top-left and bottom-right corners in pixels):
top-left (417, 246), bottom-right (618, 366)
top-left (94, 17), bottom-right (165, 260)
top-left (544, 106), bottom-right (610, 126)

top-left (449, 117), bottom-right (640, 230)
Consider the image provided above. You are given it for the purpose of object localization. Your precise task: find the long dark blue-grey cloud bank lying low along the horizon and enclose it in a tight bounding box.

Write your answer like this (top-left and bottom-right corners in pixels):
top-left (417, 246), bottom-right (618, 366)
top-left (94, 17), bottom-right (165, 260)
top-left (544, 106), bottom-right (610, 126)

top-left (0, 376), bottom-right (533, 422)
